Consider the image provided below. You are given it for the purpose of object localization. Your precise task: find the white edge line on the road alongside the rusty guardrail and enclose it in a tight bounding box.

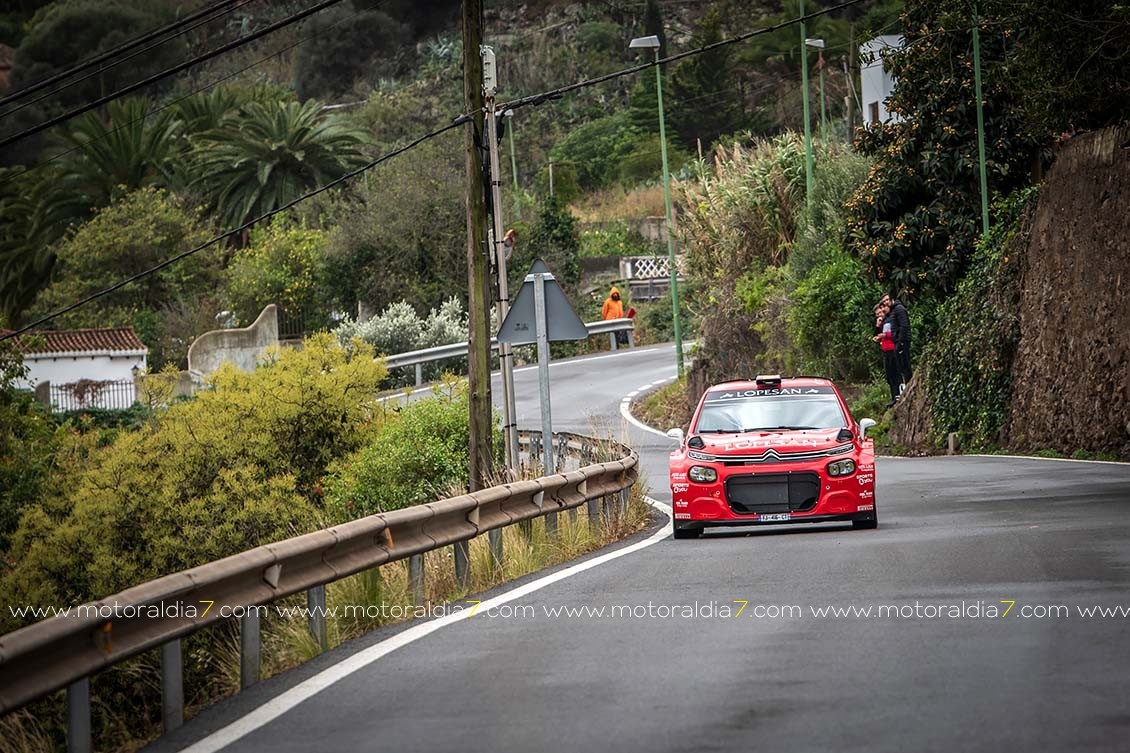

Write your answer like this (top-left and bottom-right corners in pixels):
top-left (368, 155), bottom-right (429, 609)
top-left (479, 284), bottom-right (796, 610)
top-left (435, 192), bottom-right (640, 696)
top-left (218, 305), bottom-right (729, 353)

top-left (182, 497), bottom-right (671, 753)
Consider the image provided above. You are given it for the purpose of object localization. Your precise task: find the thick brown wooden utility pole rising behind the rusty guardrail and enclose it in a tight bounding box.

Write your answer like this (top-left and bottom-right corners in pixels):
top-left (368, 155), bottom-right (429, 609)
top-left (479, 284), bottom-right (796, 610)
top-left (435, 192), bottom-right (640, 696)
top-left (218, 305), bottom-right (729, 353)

top-left (455, 0), bottom-right (492, 585)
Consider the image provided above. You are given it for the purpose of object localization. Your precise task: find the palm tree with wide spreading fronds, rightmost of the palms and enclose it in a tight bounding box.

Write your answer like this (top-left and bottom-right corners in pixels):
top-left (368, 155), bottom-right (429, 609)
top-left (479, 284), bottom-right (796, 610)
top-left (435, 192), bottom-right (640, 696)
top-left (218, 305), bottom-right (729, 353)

top-left (189, 99), bottom-right (365, 227)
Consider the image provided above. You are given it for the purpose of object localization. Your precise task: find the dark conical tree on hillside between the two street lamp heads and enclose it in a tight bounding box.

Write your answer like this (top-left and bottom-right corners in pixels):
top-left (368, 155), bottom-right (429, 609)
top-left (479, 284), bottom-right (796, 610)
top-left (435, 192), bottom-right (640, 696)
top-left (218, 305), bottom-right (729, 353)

top-left (670, 7), bottom-right (741, 149)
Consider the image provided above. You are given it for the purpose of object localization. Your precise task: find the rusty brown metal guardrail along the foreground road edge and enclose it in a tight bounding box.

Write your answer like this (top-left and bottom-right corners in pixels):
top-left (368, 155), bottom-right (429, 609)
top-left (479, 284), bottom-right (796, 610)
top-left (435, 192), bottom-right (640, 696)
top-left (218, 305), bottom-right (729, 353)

top-left (0, 432), bottom-right (640, 751)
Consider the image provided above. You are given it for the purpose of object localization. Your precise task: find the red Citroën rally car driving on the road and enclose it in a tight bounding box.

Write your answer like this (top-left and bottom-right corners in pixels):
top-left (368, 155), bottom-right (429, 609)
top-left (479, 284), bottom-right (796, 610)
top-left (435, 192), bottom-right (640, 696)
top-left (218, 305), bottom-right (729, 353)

top-left (667, 377), bottom-right (879, 538)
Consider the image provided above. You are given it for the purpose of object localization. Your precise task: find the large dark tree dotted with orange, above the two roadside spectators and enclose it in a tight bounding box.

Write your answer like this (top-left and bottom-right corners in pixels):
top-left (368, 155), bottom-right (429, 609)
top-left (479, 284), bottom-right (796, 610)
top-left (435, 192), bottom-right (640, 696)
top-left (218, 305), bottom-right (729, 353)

top-left (848, 0), bottom-right (1035, 295)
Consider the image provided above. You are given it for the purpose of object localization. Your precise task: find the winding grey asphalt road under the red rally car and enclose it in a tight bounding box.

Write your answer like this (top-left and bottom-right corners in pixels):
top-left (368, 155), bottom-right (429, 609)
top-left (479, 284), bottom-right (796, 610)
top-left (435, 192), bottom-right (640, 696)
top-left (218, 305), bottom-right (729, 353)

top-left (155, 347), bottom-right (1130, 753)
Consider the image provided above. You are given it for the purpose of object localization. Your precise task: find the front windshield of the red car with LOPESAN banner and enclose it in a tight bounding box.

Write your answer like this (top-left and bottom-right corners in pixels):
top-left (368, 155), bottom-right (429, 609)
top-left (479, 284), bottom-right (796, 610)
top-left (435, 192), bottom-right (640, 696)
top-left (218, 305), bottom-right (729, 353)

top-left (694, 387), bottom-right (848, 434)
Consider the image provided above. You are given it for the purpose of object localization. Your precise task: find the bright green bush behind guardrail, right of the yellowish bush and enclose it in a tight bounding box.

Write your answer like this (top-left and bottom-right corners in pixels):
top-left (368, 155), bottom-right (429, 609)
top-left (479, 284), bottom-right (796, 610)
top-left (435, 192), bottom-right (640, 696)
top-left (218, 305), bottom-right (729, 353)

top-left (325, 386), bottom-right (502, 522)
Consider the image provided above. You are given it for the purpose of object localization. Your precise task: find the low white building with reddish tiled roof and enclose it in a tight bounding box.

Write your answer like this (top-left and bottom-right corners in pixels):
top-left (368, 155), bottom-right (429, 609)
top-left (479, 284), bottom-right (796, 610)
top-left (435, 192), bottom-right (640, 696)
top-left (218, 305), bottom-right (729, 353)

top-left (10, 327), bottom-right (149, 410)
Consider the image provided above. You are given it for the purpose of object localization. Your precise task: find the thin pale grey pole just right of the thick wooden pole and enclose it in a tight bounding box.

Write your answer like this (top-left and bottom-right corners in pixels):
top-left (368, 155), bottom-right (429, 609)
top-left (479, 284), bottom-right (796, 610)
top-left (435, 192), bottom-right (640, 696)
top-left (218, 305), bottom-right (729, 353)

top-left (483, 46), bottom-right (518, 481)
